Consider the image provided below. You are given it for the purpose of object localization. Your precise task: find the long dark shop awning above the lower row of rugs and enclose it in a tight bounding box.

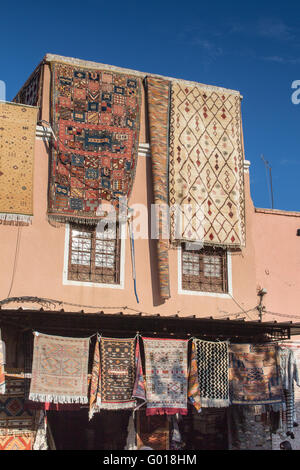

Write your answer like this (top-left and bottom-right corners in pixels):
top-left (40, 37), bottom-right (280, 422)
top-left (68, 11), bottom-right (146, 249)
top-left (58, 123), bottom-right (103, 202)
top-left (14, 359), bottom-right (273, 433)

top-left (0, 308), bottom-right (300, 341)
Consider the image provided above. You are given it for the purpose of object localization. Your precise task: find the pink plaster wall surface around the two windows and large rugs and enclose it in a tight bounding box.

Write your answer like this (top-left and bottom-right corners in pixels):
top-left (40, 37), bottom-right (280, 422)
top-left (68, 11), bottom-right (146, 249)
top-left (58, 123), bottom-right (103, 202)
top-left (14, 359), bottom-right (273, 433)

top-left (0, 64), bottom-right (300, 321)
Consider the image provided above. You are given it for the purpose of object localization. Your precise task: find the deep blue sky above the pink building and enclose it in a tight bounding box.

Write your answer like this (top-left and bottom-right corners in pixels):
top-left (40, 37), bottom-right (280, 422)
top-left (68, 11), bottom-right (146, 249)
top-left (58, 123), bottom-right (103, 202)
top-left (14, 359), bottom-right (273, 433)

top-left (0, 0), bottom-right (300, 211)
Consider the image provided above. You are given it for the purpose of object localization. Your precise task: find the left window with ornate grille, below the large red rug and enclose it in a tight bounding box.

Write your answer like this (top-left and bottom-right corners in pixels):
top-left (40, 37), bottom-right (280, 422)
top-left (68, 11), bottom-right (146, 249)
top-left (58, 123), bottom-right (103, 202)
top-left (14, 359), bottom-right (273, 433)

top-left (68, 224), bottom-right (121, 284)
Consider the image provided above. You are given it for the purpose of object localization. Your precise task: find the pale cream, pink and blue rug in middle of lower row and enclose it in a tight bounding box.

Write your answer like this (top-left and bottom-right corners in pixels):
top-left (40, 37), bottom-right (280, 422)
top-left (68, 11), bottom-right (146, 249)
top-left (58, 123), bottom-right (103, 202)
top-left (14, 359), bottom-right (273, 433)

top-left (143, 338), bottom-right (188, 415)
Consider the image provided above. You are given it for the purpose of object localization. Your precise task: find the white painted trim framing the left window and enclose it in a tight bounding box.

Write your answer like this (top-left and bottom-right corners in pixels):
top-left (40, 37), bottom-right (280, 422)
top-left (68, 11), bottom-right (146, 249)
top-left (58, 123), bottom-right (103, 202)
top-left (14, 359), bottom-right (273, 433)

top-left (63, 223), bottom-right (126, 289)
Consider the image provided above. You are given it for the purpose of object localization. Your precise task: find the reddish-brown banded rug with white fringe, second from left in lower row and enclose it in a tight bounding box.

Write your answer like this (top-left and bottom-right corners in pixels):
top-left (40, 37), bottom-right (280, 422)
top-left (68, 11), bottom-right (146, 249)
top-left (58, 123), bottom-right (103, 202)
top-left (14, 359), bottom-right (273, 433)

top-left (97, 337), bottom-right (136, 410)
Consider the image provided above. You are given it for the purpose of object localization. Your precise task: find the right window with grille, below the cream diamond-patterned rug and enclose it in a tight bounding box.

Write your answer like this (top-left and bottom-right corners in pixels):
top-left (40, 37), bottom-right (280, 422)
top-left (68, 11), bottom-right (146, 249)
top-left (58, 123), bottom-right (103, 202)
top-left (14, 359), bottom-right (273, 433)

top-left (181, 243), bottom-right (228, 293)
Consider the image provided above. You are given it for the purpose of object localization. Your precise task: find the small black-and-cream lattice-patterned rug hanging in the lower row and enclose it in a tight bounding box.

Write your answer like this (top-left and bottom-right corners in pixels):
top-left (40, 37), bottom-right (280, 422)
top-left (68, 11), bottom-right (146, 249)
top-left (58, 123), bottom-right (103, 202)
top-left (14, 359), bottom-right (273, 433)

top-left (193, 339), bottom-right (229, 408)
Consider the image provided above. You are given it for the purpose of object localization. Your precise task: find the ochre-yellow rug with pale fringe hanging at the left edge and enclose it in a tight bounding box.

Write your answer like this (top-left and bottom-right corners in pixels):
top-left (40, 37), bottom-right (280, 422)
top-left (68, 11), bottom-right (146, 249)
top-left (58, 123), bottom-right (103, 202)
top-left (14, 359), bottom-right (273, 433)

top-left (0, 102), bottom-right (38, 225)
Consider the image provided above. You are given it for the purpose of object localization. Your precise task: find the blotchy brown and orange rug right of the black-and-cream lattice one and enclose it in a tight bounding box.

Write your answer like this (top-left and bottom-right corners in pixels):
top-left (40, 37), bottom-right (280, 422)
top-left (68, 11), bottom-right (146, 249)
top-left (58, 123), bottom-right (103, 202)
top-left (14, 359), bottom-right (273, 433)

top-left (229, 344), bottom-right (284, 405)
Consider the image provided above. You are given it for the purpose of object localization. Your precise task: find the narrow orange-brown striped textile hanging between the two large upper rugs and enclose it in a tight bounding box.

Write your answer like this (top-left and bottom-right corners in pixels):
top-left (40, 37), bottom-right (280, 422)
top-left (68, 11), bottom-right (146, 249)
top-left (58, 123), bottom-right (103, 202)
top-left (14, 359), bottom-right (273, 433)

top-left (146, 77), bottom-right (170, 299)
